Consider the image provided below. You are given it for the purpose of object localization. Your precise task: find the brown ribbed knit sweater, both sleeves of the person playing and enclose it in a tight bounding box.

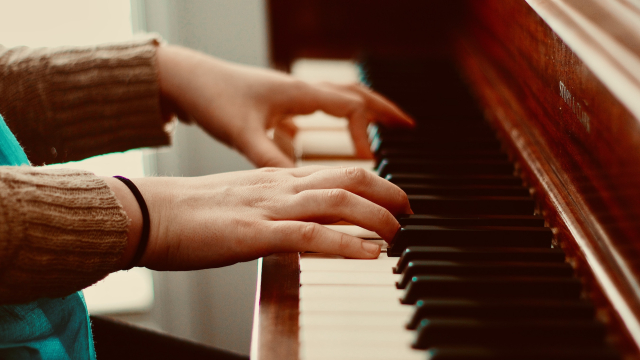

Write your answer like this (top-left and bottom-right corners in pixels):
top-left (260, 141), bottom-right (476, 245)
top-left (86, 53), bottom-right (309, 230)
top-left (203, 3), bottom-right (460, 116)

top-left (0, 38), bottom-right (169, 304)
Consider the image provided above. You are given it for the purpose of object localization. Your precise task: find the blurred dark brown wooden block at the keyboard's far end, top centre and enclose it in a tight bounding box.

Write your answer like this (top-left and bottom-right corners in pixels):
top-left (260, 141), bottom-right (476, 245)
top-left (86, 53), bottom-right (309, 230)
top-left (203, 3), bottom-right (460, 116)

top-left (267, 0), bottom-right (465, 70)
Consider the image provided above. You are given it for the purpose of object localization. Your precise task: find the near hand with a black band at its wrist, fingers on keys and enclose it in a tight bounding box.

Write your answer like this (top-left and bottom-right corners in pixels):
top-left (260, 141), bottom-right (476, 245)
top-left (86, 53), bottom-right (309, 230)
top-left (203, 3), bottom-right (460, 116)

top-left (105, 166), bottom-right (411, 270)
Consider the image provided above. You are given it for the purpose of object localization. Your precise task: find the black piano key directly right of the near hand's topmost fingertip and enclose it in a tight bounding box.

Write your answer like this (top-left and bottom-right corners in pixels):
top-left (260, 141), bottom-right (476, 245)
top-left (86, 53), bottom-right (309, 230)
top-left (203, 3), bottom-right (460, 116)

top-left (408, 195), bottom-right (535, 215)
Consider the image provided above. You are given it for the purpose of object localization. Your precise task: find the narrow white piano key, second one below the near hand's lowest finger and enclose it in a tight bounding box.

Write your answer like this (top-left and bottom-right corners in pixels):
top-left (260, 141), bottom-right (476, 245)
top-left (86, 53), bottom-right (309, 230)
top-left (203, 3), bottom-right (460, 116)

top-left (300, 271), bottom-right (400, 286)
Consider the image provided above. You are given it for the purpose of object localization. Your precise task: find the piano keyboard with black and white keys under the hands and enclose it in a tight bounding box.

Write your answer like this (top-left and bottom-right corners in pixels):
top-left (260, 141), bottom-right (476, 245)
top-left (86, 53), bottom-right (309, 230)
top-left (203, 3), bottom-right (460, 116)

top-left (299, 59), bottom-right (619, 360)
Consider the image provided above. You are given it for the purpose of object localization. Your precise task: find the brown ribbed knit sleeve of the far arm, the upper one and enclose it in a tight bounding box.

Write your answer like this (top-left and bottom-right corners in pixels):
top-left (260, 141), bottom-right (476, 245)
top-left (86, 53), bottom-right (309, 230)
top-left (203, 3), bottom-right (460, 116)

top-left (0, 36), bottom-right (169, 165)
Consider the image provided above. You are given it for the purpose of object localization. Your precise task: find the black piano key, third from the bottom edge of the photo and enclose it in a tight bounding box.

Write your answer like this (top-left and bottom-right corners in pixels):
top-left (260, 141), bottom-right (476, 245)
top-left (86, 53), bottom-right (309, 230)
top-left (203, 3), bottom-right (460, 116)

top-left (407, 299), bottom-right (595, 330)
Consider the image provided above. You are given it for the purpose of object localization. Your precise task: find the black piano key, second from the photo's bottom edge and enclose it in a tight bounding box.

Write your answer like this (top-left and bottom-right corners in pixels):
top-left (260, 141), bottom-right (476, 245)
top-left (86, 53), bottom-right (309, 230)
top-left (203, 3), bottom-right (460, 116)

top-left (413, 319), bottom-right (605, 349)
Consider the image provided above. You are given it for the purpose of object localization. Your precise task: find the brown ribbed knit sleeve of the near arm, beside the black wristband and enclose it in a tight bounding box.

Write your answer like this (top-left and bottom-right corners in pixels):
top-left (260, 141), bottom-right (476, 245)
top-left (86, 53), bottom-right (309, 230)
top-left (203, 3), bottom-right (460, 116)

top-left (0, 166), bottom-right (129, 304)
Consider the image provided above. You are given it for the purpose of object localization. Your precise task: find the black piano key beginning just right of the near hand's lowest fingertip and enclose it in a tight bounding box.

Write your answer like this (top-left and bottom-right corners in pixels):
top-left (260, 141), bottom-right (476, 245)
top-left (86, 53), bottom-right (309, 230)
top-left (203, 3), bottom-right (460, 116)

top-left (387, 225), bottom-right (553, 256)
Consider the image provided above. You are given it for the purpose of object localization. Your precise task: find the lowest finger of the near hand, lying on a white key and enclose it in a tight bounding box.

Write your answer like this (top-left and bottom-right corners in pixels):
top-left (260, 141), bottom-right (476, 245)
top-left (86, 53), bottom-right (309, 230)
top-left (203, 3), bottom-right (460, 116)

top-left (269, 221), bottom-right (380, 259)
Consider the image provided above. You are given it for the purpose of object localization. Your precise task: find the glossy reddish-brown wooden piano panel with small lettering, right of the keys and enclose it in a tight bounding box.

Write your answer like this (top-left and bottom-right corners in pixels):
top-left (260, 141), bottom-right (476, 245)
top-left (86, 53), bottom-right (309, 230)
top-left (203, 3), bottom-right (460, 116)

top-left (458, 1), bottom-right (640, 358)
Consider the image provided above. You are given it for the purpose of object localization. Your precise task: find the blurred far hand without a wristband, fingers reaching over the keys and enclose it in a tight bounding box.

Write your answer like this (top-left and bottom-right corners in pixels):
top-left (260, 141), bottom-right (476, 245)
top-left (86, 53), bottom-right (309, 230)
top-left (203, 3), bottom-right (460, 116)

top-left (158, 46), bottom-right (413, 167)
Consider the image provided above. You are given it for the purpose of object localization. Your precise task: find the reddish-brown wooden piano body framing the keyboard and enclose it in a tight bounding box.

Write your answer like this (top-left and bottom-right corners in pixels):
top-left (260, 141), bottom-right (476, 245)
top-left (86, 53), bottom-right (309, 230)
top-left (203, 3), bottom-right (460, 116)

top-left (252, 0), bottom-right (640, 359)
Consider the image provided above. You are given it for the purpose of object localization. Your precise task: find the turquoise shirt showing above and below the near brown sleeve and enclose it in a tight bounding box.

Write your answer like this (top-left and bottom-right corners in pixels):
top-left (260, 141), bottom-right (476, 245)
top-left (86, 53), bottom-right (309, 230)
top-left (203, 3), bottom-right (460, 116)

top-left (0, 116), bottom-right (96, 360)
